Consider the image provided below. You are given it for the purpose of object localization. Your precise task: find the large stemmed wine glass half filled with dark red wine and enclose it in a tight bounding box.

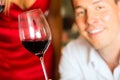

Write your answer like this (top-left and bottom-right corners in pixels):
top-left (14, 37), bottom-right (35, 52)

top-left (18, 9), bottom-right (51, 80)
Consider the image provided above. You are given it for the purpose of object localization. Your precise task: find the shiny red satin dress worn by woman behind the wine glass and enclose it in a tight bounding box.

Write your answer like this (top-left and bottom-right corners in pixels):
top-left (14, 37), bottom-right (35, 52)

top-left (0, 0), bottom-right (53, 80)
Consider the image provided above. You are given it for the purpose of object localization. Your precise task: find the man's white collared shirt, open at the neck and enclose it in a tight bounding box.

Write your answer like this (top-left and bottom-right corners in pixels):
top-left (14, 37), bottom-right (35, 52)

top-left (59, 37), bottom-right (120, 80)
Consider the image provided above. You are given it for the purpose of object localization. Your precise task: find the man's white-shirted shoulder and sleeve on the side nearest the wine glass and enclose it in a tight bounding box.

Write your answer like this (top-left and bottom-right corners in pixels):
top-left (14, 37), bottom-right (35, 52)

top-left (59, 37), bottom-right (91, 80)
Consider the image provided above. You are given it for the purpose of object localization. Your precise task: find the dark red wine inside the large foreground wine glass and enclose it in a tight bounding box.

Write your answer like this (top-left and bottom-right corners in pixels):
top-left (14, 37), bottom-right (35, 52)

top-left (22, 40), bottom-right (50, 57)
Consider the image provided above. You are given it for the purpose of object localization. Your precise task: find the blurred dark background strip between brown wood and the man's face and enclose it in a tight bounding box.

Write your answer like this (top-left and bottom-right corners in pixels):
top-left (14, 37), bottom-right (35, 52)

top-left (61, 0), bottom-right (79, 46)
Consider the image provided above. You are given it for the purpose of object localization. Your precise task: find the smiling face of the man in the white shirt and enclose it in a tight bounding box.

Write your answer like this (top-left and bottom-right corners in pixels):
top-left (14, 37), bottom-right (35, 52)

top-left (73, 0), bottom-right (120, 49)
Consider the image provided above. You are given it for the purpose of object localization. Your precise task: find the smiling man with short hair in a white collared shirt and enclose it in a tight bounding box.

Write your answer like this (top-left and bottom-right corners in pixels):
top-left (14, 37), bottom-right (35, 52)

top-left (60, 0), bottom-right (120, 80)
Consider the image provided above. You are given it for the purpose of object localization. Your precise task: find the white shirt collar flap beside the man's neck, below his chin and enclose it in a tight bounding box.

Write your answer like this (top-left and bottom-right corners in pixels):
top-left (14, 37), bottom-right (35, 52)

top-left (88, 48), bottom-right (112, 79)
